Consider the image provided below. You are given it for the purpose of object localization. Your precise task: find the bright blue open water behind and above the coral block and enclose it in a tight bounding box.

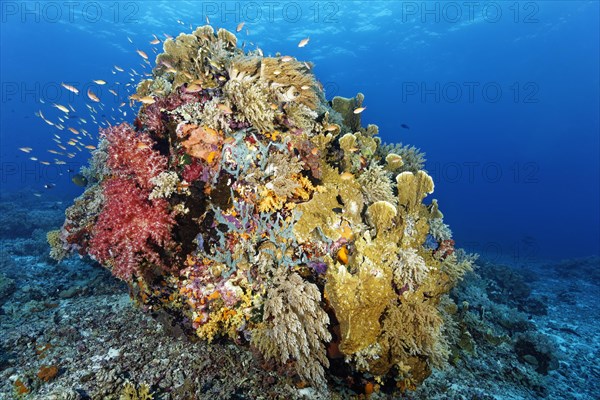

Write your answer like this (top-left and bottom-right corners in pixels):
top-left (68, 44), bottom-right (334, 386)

top-left (0, 1), bottom-right (600, 264)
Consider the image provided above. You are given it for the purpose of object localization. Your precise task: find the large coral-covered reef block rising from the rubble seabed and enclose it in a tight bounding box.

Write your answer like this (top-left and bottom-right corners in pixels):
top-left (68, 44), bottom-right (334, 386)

top-left (48, 26), bottom-right (473, 393)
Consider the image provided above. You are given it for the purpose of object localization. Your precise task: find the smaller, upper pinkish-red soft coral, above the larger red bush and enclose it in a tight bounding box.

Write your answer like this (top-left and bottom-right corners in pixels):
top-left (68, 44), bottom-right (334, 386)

top-left (101, 123), bottom-right (167, 190)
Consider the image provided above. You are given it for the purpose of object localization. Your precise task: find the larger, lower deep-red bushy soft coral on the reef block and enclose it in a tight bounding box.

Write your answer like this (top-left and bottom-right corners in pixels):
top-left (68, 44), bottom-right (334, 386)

top-left (89, 178), bottom-right (175, 280)
